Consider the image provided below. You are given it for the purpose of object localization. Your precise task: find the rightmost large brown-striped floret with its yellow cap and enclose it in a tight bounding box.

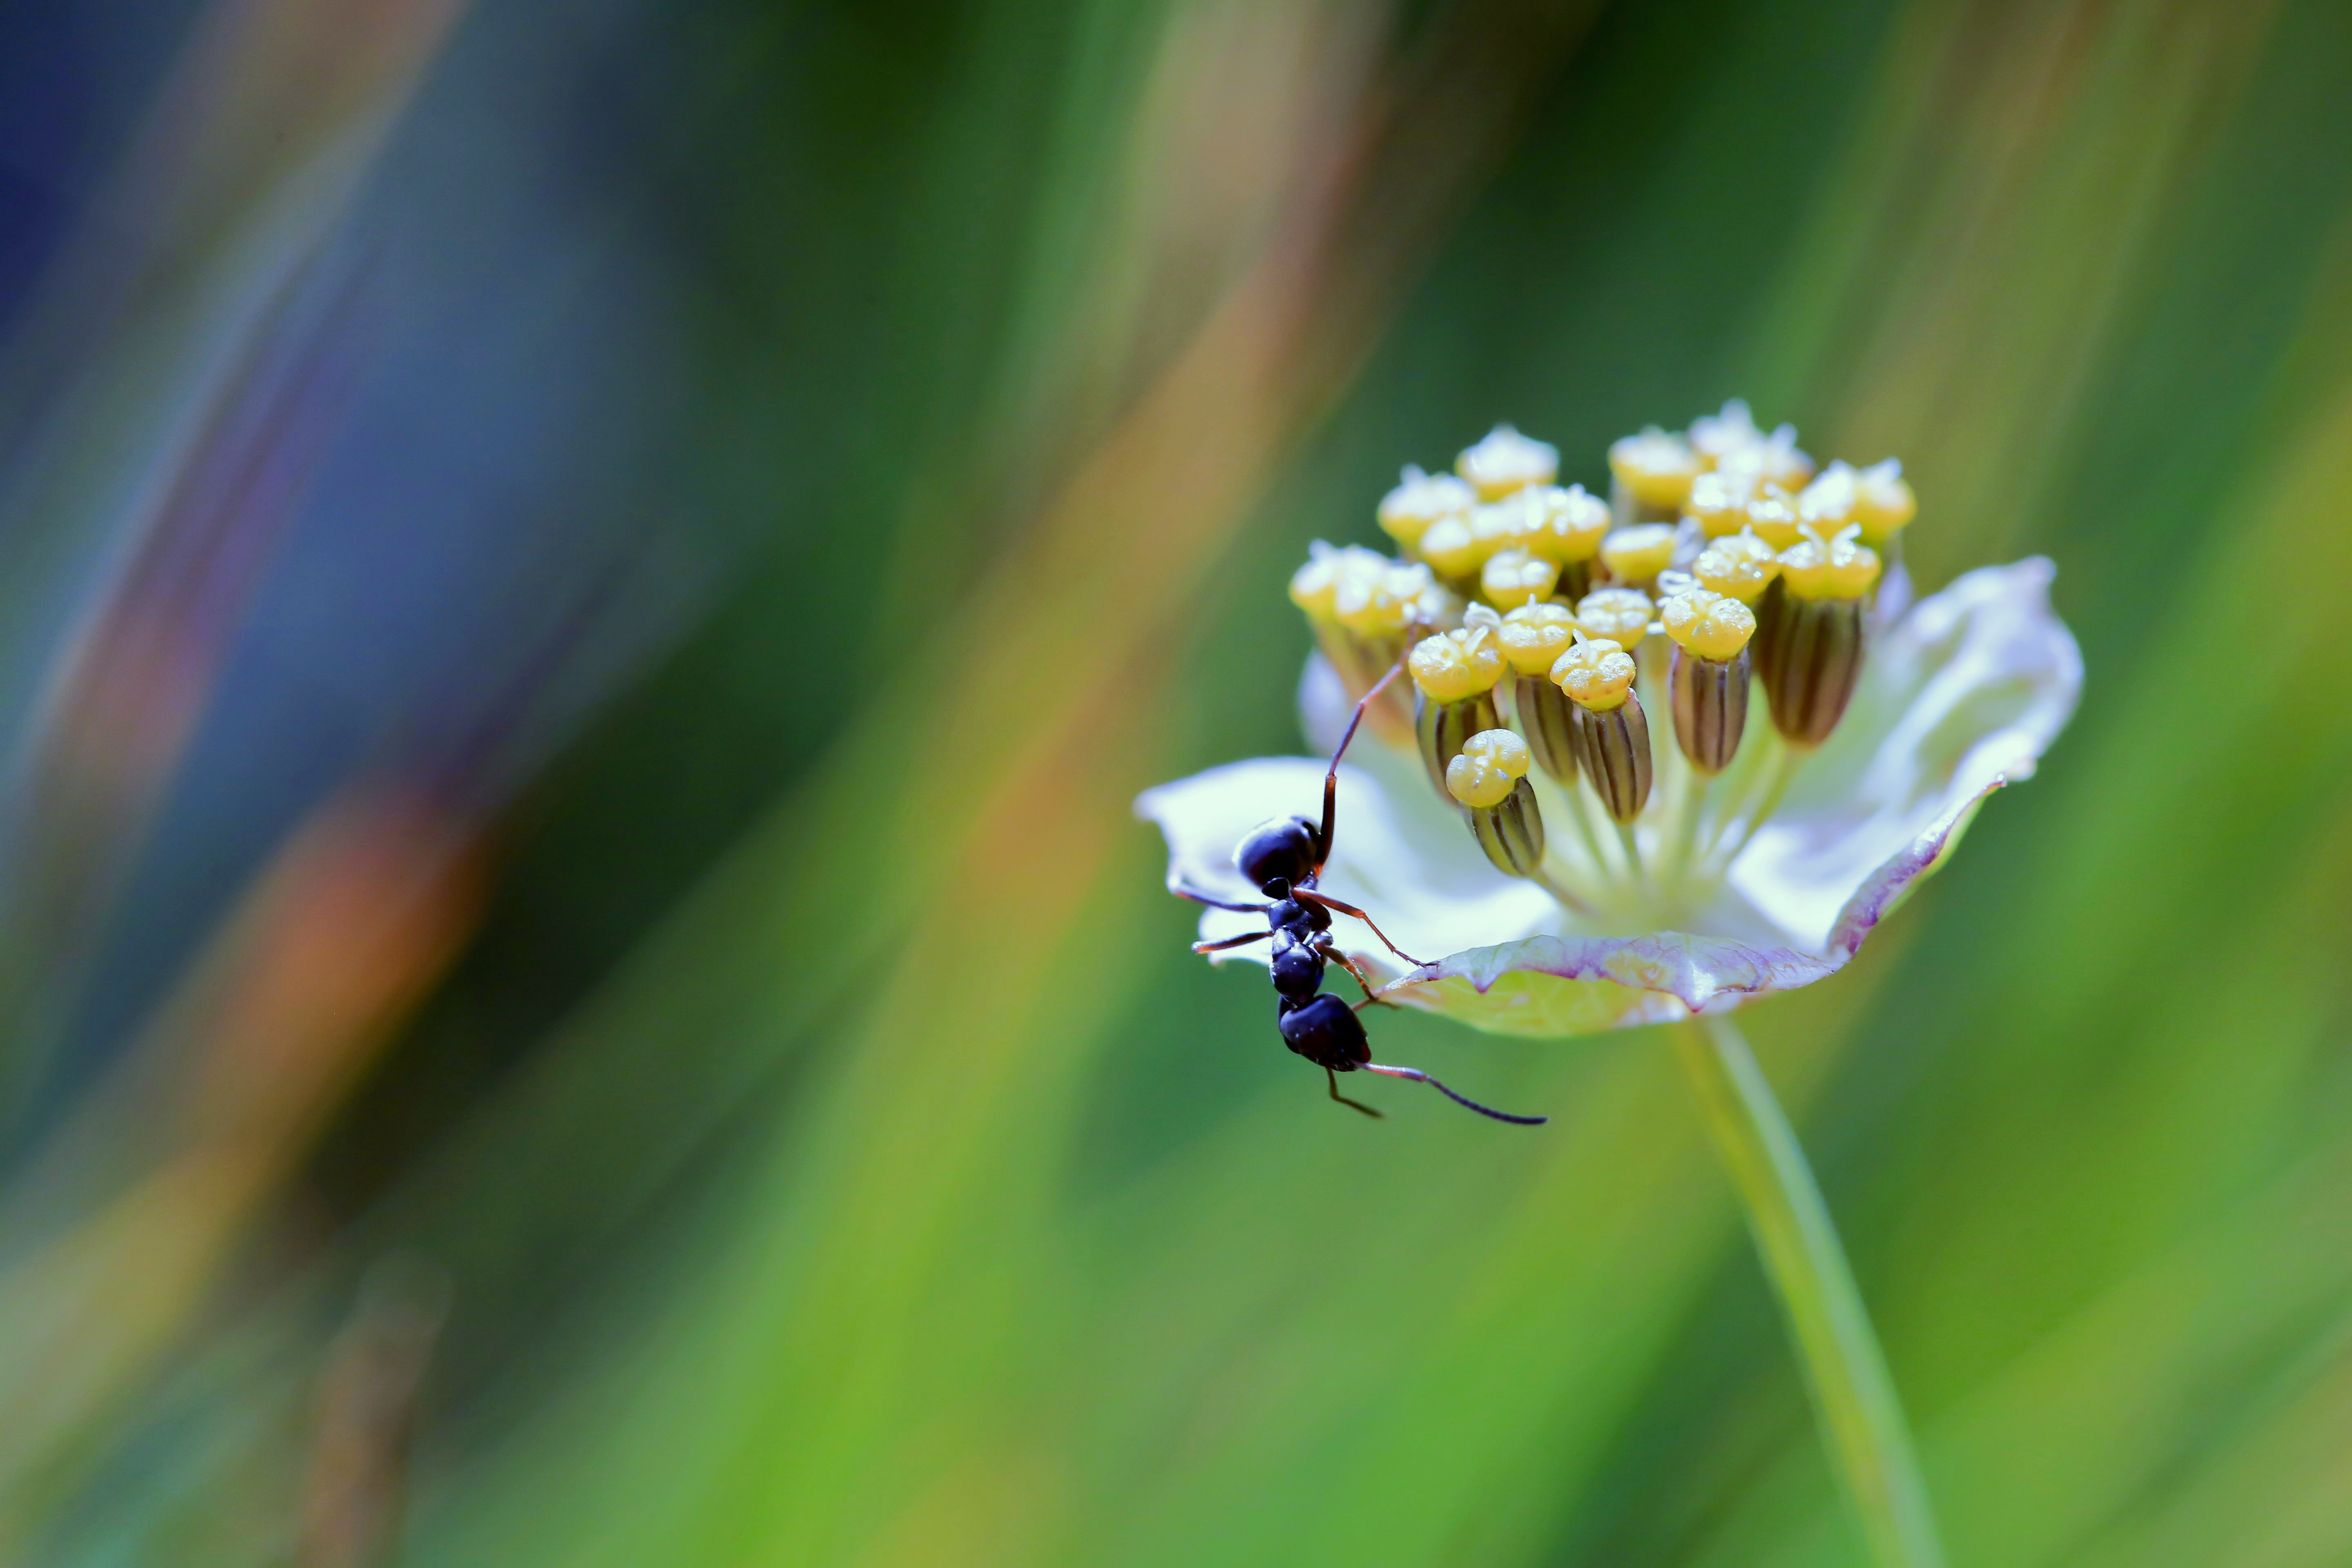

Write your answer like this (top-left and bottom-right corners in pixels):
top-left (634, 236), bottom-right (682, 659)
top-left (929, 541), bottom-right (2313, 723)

top-left (1755, 524), bottom-right (1879, 748)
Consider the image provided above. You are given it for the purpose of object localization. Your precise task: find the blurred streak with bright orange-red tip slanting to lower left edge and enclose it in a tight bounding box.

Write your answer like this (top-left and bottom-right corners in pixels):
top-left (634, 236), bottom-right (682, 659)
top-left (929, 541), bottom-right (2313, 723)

top-left (0, 790), bottom-right (482, 1530)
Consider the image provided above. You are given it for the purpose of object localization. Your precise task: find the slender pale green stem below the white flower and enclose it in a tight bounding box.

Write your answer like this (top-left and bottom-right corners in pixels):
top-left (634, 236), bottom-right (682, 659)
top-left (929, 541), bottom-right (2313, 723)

top-left (1675, 1018), bottom-right (1943, 1568)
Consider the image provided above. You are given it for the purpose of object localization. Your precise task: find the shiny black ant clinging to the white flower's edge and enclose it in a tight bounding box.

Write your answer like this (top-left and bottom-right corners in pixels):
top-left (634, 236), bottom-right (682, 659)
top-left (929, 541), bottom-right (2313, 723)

top-left (1169, 658), bottom-right (1548, 1126)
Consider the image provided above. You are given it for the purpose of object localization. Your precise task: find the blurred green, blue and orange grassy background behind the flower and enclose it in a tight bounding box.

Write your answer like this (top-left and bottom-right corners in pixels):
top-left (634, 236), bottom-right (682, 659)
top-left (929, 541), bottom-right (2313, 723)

top-left (0, 0), bottom-right (2352, 1568)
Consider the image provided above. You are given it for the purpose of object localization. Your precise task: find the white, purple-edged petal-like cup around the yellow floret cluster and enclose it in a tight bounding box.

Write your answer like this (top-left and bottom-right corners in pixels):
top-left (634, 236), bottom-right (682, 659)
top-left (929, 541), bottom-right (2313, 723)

top-left (1136, 472), bottom-right (2082, 1034)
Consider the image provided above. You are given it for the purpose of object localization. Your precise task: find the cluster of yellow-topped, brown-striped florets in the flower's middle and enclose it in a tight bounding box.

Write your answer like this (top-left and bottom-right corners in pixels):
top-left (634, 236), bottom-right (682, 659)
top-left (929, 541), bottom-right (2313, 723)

top-left (1291, 402), bottom-right (1917, 926)
